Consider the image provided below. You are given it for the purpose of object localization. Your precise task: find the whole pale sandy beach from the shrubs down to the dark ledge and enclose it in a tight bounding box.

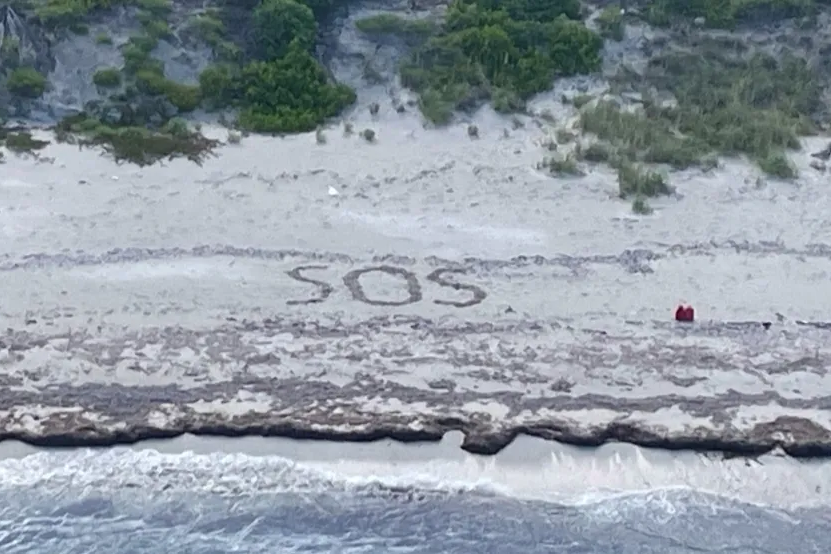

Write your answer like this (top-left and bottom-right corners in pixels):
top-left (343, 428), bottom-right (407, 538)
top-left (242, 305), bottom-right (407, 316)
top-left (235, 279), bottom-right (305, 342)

top-left (0, 95), bottom-right (831, 456)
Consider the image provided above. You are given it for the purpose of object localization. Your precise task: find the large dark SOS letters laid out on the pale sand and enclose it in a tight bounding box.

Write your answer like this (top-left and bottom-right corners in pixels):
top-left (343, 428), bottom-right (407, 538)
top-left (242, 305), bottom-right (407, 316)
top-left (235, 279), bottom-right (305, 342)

top-left (286, 265), bottom-right (488, 308)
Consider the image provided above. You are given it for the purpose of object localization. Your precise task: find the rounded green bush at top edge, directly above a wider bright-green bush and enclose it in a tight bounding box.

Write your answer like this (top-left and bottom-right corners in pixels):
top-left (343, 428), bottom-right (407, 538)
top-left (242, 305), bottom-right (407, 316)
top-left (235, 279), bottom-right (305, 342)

top-left (252, 0), bottom-right (317, 60)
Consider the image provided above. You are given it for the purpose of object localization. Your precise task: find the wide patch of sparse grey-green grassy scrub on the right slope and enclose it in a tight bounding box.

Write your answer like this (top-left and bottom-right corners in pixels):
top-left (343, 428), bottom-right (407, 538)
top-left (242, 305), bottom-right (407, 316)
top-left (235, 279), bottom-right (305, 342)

top-left (580, 48), bottom-right (822, 178)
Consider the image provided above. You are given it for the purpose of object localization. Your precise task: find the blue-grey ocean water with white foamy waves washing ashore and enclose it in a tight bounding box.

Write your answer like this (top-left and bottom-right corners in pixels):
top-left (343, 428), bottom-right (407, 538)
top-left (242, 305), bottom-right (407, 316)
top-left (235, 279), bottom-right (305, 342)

top-left (0, 436), bottom-right (831, 554)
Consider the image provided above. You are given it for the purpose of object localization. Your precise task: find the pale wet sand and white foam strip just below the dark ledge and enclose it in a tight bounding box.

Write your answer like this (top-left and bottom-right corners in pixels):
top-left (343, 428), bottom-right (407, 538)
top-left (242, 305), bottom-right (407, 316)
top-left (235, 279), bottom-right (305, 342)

top-left (0, 432), bottom-right (831, 510)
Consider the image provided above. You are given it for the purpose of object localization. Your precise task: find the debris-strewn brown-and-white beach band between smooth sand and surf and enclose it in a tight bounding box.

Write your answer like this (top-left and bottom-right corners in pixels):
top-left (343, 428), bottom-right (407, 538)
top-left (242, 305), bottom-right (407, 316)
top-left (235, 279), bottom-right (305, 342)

top-left (0, 308), bottom-right (831, 458)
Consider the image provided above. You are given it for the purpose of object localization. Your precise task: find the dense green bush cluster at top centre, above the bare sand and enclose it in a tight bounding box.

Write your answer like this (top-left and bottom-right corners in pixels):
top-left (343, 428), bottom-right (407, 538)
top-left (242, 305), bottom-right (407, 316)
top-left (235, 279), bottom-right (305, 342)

top-left (394, 0), bottom-right (602, 124)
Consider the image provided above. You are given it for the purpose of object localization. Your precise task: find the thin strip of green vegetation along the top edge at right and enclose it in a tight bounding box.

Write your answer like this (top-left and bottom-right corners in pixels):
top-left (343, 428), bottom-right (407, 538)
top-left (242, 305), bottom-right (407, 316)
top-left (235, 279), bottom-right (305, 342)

top-left (647, 0), bottom-right (816, 28)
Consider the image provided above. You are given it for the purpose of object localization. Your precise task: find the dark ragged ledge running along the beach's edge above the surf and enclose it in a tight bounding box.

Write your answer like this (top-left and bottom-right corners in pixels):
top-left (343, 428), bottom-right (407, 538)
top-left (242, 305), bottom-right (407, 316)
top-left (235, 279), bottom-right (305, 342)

top-left (0, 414), bottom-right (831, 458)
